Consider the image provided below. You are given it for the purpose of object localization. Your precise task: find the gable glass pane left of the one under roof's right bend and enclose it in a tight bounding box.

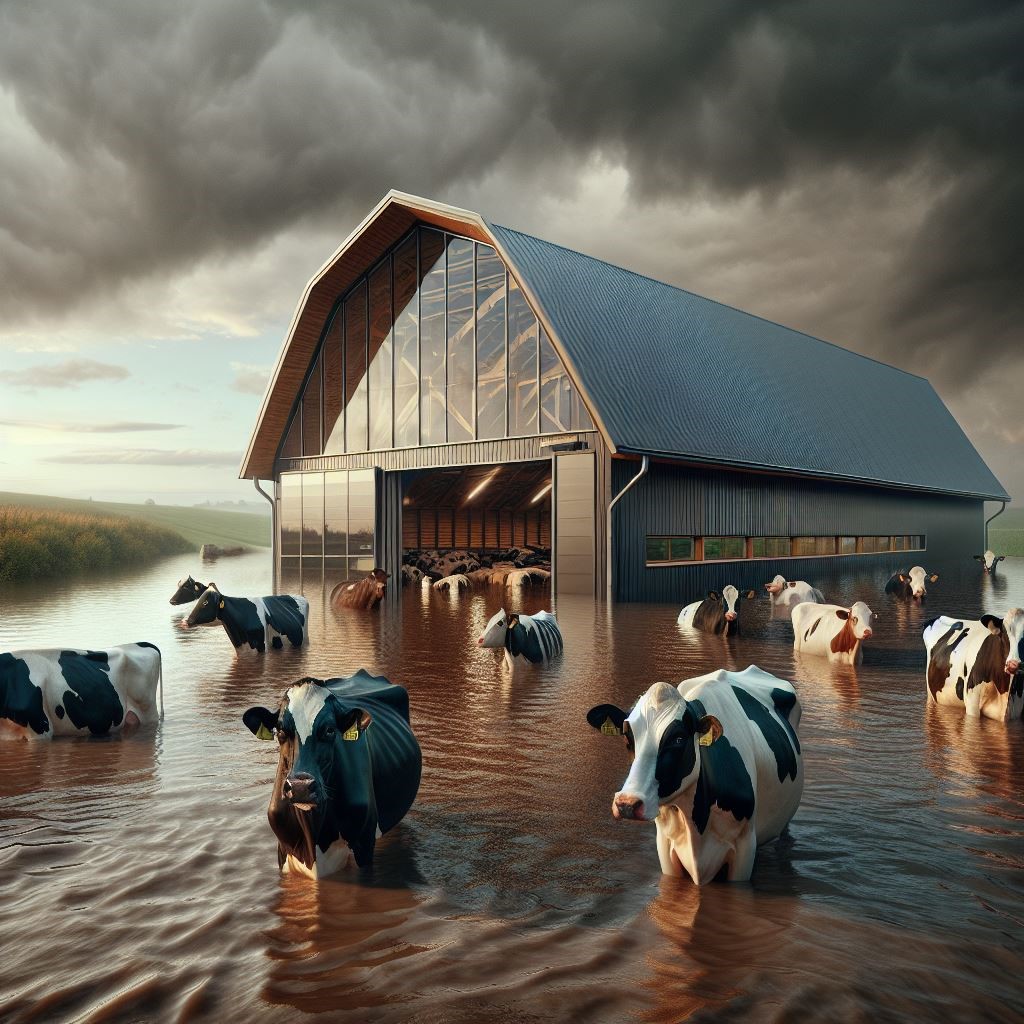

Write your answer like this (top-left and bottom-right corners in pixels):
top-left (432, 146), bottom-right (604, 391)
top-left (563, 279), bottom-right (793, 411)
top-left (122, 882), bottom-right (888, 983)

top-left (446, 236), bottom-right (476, 441)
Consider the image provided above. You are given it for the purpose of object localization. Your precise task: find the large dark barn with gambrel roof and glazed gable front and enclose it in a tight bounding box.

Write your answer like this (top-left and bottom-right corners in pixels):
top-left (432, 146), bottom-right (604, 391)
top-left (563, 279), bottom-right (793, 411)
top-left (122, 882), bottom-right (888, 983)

top-left (240, 191), bottom-right (1009, 601)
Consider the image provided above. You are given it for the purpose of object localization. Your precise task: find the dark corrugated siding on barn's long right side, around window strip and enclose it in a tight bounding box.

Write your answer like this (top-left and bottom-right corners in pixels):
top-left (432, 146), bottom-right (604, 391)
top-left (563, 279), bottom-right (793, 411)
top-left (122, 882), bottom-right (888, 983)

top-left (611, 459), bottom-right (984, 601)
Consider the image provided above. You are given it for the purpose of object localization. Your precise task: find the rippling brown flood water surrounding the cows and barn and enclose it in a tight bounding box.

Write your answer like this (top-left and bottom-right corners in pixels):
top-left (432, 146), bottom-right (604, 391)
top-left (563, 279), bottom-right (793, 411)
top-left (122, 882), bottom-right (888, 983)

top-left (0, 554), bottom-right (1024, 1024)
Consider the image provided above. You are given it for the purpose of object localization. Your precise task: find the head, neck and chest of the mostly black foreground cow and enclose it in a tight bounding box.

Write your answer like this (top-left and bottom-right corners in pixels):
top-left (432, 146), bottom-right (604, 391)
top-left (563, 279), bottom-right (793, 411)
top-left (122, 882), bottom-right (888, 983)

top-left (242, 677), bottom-right (377, 867)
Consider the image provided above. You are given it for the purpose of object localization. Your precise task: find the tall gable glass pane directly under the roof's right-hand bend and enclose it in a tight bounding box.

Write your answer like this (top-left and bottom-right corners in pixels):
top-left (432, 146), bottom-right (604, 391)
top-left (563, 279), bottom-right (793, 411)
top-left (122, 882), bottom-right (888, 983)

top-left (476, 246), bottom-right (506, 438)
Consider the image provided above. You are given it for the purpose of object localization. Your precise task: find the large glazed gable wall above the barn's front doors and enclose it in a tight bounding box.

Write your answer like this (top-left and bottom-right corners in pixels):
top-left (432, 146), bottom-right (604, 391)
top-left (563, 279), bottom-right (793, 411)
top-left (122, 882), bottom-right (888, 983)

top-left (281, 227), bottom-right (594, 460)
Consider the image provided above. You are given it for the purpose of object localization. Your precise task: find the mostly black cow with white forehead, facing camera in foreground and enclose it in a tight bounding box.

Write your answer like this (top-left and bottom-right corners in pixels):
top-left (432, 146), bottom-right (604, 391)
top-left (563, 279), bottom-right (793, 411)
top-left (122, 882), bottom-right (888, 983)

top-left (242, 670), bottom-right (422, 879)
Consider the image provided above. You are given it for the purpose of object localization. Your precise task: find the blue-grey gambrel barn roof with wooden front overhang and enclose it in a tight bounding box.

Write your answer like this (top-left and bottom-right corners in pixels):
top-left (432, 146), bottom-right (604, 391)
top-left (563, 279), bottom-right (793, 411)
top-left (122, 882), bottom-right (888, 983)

top-left (241, 193), bottom-right (1008, 501)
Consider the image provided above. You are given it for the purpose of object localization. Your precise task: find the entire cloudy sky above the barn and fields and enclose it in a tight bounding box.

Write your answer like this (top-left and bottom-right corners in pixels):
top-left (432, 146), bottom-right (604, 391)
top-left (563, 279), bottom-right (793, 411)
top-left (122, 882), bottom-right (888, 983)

top-left (0, 0), bottom-right (1024, 502)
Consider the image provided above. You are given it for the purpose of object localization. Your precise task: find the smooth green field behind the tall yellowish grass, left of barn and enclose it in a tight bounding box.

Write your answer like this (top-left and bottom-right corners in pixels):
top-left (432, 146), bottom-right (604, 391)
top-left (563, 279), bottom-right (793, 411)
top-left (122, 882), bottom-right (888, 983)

top-left (0, 490), bottom-right (270, 551)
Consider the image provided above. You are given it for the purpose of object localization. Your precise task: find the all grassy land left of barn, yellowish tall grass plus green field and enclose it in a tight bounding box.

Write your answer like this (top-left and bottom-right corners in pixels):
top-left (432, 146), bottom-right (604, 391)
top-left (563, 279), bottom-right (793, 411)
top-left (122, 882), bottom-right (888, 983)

top-left (0, 492), bottom-right (270, 582)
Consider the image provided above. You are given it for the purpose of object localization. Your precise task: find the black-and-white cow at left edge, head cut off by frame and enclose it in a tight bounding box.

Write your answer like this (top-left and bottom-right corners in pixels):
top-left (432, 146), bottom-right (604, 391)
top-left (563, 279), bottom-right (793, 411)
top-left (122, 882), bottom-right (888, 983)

top-left (0, 642), bottom-right (164, 739)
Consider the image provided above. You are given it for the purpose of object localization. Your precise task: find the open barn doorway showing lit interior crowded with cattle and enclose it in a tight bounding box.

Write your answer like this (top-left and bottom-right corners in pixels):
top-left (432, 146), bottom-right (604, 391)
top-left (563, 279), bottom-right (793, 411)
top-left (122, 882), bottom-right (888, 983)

top-left (401, 459), bottom-right (552, 587)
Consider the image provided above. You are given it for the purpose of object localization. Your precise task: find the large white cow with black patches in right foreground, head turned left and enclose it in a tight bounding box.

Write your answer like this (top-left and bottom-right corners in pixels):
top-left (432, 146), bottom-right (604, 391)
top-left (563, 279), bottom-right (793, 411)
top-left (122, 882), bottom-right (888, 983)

top-left (587, 665), bottom-right (804, 886)
